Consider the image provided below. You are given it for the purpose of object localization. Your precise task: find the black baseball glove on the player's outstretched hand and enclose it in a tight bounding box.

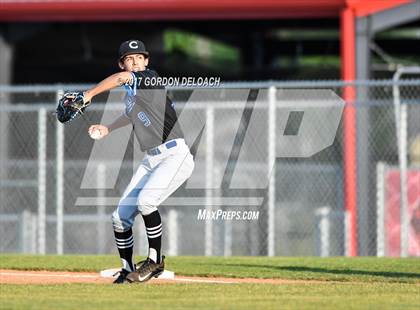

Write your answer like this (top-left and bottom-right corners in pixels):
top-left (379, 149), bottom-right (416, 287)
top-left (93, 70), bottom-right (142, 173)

top-left (56, 92), bottom-right (90, 123)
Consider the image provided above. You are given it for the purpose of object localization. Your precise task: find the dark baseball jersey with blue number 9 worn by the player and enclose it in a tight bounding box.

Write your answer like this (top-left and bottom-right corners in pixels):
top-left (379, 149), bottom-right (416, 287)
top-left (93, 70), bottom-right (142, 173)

top-left (125, 69), bottom-right (184, 151)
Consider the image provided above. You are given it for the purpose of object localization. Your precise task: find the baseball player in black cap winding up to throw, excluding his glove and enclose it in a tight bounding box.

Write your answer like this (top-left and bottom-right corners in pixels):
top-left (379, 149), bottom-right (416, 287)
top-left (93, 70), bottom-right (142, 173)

top-left (83, 40), bottom-right (194, 283)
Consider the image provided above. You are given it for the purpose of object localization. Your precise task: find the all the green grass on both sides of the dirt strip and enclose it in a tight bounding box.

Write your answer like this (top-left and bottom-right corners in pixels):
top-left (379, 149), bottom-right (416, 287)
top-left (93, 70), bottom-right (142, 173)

top-left (0, 255), bottom-right (420, 310)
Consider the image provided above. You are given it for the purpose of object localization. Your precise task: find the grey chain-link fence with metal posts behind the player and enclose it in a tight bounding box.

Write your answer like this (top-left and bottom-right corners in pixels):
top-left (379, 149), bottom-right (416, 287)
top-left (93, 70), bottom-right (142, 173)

top-left (0, 80), bottom-right (420, 256)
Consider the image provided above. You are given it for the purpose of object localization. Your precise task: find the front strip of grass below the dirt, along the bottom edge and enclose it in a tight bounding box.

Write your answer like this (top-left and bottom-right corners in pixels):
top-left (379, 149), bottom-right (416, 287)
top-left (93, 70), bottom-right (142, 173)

top-left (0, 283), bottom-right (420, 310)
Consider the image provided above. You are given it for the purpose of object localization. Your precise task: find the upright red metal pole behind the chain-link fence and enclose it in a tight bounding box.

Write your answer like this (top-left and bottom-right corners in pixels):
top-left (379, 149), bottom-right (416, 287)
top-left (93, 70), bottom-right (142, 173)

top-left (341, 8), bottom-right (357, 256)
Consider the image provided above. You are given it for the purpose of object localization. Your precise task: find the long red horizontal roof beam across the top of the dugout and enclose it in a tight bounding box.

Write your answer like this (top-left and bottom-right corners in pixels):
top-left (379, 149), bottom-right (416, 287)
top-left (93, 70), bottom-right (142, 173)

top-left (0, 0), bottom-right (410, 21)
